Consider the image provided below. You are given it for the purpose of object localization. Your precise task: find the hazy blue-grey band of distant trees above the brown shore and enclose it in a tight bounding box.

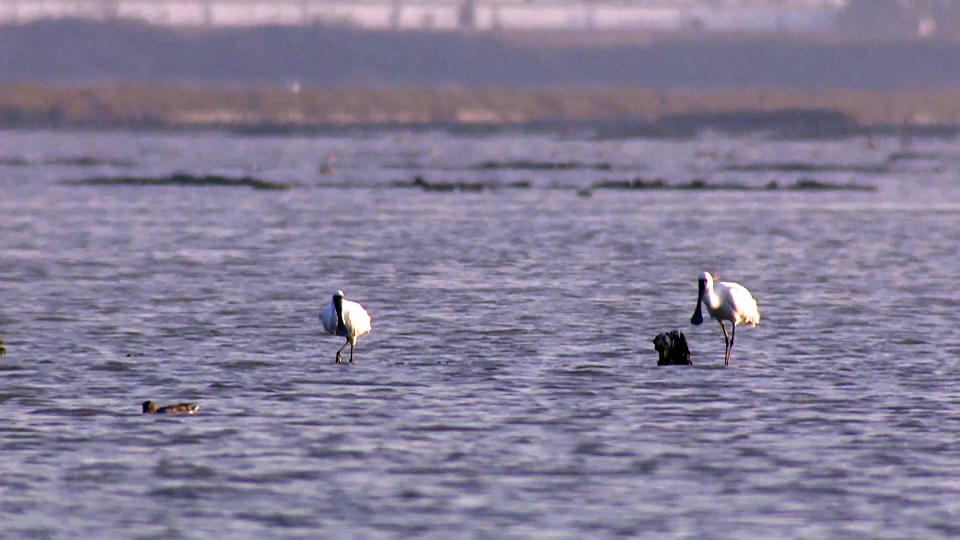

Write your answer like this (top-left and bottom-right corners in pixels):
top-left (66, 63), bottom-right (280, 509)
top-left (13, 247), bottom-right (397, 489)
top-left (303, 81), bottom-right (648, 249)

top-left (0, 20), bottom-right (960, 90)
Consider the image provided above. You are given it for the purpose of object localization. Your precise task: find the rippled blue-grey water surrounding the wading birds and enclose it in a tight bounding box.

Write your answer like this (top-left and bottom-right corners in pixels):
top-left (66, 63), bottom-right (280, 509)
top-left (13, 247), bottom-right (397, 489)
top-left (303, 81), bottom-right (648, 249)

top-left (0, 131), bottom-right (960, 538)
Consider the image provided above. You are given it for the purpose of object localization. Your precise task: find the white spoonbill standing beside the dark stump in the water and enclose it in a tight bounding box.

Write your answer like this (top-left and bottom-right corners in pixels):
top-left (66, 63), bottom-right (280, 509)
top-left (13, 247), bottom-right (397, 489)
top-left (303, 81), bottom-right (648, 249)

top-left (690, 272), bottom-right (760, 366)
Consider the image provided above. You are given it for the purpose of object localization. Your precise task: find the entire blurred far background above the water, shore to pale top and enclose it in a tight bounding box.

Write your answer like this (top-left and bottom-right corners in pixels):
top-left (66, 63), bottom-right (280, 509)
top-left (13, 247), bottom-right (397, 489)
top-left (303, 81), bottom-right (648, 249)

top-left (0, 0), bottom-right (960, 129)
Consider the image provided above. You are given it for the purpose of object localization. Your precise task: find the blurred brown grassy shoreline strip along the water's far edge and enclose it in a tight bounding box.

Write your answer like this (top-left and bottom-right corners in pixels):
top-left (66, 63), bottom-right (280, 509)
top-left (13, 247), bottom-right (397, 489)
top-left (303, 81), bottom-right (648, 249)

top-left (0, 84), bottom-right (960, 137)
